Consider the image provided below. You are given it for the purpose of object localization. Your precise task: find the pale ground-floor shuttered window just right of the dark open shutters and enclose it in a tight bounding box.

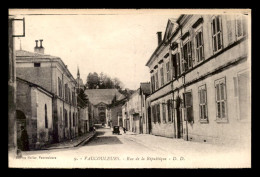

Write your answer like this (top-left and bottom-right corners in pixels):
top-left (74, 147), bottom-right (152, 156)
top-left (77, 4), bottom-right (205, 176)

top-left (199, 85), bottom-right (208, 121)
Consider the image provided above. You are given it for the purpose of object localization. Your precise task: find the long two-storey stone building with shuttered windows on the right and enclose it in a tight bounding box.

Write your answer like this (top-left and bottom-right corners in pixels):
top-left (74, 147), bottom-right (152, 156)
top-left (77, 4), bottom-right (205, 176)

top-left (146, 14), bottom-right (251, 143)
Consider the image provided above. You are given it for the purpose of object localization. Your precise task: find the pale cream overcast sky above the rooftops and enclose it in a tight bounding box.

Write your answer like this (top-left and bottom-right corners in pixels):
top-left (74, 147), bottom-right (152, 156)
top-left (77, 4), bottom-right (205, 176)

top-left (11, 10), bottom-right (182, 89)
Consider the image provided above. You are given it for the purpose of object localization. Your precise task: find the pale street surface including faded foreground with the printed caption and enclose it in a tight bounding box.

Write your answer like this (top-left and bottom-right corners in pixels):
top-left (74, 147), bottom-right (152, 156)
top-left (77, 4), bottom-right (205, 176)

top-left (10, 128), bottom-right (250, 168)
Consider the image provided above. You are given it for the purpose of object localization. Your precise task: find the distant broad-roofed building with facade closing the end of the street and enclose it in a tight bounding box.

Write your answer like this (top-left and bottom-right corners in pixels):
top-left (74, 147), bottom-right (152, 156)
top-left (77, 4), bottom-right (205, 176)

top-left (85, 89), bottom-right (124, 125)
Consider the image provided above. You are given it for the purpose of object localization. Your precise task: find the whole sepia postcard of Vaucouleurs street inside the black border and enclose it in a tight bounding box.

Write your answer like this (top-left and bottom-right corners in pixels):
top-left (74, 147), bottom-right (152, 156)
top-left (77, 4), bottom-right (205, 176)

top-left (8, 9), bottom-right (252, 169)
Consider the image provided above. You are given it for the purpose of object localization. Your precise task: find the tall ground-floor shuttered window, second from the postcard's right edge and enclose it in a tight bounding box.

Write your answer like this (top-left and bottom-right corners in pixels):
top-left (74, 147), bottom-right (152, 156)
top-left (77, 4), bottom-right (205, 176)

top-left (215, 78), bottom-right (227, 119)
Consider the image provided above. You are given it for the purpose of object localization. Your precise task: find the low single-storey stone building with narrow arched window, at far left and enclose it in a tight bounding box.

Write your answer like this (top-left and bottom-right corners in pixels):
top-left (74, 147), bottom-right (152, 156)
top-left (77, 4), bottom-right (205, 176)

top-left (16, 77), bottom-right (53, 150)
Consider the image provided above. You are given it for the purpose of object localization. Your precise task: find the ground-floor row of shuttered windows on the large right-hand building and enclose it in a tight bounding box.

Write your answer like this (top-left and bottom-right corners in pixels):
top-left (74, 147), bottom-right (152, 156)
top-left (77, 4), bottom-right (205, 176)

top-left (152, 78), bottom-right (227, 123)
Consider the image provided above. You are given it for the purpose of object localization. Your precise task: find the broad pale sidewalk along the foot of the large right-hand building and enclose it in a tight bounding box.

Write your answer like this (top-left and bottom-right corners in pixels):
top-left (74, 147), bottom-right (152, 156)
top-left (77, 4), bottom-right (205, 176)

top-left (123, 132), bottom-right (250, 156)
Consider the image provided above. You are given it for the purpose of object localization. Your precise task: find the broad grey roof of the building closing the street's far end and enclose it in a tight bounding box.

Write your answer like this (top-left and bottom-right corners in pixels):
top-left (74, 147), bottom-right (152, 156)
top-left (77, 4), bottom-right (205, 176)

top-left (85, 89), bottom-right (125, 105)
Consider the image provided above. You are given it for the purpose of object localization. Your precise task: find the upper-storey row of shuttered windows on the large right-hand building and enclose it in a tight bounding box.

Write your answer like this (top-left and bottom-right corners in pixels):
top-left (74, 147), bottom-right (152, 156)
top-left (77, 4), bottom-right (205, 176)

top-left (151, 15), bottom-right (246, 92)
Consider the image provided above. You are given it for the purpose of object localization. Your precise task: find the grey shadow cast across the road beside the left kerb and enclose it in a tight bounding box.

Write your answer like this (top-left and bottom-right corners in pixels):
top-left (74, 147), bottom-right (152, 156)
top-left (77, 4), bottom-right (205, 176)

top-left (84, 136), bottom-right (123, 146)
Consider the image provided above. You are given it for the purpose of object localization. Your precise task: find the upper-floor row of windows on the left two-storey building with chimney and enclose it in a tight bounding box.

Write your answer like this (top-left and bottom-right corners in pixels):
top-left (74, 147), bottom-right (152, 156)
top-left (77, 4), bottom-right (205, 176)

top-left (58, 77), bottom-right (76, 106)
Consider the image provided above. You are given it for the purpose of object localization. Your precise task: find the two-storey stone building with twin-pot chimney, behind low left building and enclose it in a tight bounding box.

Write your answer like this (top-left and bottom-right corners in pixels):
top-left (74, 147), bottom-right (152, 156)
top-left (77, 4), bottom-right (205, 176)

top-left (16, 40), bottom-right (78, 142)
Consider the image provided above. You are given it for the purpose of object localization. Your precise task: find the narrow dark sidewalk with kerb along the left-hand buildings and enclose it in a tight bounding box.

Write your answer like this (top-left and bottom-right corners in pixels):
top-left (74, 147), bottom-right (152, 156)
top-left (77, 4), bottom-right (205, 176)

top-left (42, 132), bottom-right (96, 150)
